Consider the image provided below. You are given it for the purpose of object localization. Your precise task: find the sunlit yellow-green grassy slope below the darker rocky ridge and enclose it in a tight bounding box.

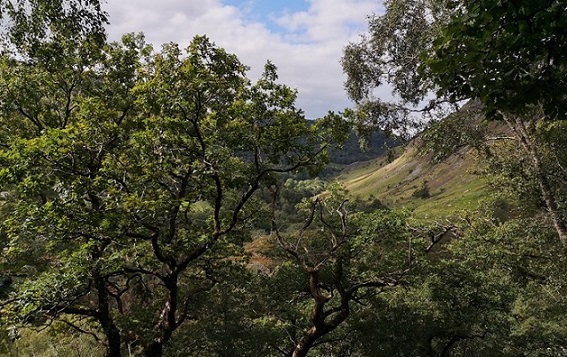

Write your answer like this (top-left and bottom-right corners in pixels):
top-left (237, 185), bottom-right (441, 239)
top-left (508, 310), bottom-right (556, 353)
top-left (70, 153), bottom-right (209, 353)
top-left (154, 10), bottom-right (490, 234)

top-left (337, 144), bottom-right (490, 219)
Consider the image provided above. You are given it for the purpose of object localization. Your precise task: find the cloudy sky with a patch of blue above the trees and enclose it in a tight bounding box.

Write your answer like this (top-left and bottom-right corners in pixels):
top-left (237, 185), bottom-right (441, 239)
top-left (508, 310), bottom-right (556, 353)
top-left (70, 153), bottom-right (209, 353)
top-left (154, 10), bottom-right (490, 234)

top-left (105, 0), bottom-right (381, 119)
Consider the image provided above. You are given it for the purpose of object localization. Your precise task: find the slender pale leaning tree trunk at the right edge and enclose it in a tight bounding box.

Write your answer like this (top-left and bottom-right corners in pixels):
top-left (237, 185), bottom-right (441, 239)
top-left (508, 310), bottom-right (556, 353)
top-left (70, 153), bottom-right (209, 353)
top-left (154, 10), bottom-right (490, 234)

top-left (504, 112), bottom-right (567, 250)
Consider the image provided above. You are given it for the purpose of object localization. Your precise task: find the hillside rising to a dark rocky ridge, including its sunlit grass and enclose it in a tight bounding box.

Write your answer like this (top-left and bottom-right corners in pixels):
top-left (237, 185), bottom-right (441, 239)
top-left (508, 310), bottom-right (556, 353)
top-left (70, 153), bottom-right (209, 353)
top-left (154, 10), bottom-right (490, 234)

top-left (337, 103), bottom-right (511, 219)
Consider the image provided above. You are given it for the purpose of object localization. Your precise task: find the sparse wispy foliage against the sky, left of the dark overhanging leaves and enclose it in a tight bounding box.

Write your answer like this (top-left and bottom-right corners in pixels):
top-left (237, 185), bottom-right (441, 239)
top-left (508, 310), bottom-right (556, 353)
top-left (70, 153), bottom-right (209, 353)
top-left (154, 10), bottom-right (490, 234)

top-left (341, 0), bottom-right (451, 140)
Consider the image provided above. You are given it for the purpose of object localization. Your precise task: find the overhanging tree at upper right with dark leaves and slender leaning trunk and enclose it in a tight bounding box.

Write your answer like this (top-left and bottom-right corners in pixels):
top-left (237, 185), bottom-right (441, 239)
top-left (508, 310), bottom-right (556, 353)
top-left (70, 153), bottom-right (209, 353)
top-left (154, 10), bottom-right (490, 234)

top-left (343, 0), bottom-right (567, 247)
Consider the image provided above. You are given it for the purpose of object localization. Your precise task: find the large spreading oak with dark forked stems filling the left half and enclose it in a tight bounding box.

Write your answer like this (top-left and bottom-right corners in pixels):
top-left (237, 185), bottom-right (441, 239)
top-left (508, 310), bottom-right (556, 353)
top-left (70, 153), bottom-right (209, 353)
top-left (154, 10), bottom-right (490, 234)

top-left (0, 30), bottom-right (336, 356)
